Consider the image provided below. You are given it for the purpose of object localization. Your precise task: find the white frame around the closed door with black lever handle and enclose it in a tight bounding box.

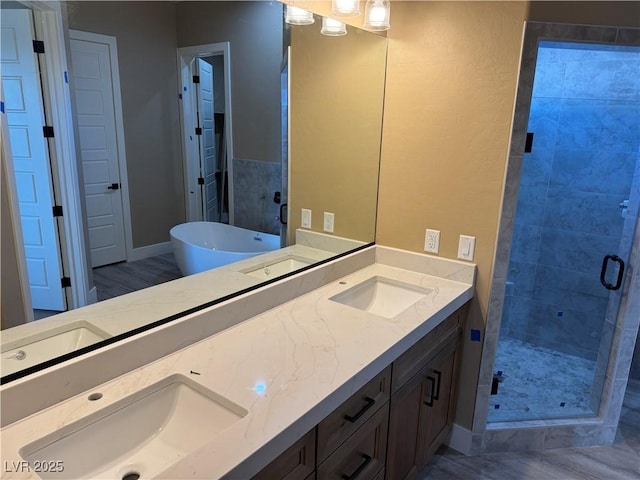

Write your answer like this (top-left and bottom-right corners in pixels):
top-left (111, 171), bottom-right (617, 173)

top-left (69, 29), bottom-right (134, 261)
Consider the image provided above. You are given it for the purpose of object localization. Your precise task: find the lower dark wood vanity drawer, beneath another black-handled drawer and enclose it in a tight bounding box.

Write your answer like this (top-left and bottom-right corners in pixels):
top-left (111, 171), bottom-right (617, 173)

top-left (317, 402), bottom-right (389, 480)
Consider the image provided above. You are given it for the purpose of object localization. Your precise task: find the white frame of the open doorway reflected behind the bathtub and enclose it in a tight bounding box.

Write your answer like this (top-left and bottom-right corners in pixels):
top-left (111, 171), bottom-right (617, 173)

top-left (178, 42), bottom-right (234, 225)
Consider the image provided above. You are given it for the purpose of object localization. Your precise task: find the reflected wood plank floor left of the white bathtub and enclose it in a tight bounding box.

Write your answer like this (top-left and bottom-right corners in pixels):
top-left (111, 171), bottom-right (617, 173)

top-left (93, 253), bottom-right (182, 301)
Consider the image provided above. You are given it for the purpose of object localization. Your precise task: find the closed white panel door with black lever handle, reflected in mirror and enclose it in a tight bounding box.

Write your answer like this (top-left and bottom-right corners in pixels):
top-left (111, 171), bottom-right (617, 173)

top-left (71, 39), bottom-right (127, 267)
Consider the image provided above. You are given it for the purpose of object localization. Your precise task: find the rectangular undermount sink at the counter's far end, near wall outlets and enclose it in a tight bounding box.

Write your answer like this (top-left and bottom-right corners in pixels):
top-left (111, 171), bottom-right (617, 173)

top-left (329, 276), bottom-right (432, 318)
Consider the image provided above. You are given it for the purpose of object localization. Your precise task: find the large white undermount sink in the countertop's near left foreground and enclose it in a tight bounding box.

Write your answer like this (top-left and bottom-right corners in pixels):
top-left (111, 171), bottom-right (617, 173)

top-left (20, 375), bottom-right (248, 480)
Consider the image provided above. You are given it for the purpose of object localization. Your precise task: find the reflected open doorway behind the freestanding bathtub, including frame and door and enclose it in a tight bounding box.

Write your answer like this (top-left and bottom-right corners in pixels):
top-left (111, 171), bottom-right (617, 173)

top-left (178, 42), bottom-right (234, 225)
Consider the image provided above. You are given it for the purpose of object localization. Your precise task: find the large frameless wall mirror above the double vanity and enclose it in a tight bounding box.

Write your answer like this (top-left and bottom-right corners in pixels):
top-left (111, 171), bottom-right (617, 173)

top-left (1, 1), bottom-right (387, 382)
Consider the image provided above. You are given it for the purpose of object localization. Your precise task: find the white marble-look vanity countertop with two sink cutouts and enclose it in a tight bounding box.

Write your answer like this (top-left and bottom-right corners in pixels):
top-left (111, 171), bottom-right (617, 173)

top-left (1, 247), bottom-right (475, 479)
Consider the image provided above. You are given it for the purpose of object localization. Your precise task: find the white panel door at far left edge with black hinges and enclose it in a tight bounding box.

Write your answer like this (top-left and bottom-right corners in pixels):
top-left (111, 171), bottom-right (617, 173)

top-left (0, 9), bottom-right (67, 311)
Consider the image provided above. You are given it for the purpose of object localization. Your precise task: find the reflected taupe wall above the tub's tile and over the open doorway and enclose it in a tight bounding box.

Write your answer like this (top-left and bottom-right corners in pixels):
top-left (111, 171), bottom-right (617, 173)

top-left (177, 2), bottom-right (282, 162)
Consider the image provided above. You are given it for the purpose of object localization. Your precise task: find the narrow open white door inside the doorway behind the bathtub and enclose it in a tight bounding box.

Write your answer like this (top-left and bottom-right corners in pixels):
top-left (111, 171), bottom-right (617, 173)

top-left (198, 59), bottom-right (219, 222)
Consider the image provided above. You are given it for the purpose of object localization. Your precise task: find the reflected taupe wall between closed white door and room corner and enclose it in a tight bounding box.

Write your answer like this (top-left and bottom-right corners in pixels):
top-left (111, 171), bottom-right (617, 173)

top-left (67, 1), bottom-right (185, 247)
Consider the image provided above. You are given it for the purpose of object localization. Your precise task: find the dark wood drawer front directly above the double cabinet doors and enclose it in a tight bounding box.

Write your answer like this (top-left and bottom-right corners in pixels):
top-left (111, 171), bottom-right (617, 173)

top-left (391, 305), bottom-right (466, 393)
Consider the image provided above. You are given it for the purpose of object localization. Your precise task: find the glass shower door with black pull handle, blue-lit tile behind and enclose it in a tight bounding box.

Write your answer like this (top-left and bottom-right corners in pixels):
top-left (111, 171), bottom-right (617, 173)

top-left (489, 42), bottom-right (640, 422)
